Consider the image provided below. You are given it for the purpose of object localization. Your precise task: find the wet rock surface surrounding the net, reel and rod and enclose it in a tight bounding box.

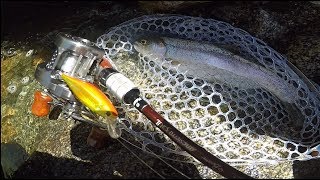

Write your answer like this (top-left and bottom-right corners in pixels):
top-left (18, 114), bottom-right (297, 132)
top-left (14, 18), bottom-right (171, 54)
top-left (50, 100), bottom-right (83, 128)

top-left (1, 1), bottom-right (320, 178)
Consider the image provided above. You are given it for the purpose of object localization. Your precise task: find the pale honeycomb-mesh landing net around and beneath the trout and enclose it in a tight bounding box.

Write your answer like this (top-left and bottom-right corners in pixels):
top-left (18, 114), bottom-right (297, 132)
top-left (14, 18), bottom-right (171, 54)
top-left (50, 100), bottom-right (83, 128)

top-left (96, 15), bottom-right (320, 164)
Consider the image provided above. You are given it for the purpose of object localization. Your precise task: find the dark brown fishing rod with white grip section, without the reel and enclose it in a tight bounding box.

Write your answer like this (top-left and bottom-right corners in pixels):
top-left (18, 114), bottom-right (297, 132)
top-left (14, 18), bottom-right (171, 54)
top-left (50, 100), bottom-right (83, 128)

top-left (98, 60), bottom-right (252, 179)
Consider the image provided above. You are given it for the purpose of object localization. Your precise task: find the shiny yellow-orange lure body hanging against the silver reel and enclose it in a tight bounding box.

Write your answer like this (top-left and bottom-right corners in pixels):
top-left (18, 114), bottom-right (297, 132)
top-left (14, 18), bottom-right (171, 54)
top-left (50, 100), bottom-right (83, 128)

top-left (61, 74), bottom-right (118, 119)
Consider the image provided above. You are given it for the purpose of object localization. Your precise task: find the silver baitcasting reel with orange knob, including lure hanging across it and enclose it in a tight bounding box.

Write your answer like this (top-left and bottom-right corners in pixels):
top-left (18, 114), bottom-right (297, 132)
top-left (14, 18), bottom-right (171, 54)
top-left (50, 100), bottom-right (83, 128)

top-left (32, 34), bottom-right (120, 138)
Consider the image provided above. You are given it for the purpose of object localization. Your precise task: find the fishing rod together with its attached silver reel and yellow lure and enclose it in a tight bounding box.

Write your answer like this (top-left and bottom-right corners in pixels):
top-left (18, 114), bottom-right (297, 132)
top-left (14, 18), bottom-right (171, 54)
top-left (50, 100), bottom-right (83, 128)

top-left (32, 34), bottom-right (252, 179)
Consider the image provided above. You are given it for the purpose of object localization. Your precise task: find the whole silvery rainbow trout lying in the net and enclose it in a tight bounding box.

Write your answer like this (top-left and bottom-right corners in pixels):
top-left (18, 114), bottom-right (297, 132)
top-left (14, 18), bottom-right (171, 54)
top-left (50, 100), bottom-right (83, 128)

top-left (133, 36), bottom-right (297, 103)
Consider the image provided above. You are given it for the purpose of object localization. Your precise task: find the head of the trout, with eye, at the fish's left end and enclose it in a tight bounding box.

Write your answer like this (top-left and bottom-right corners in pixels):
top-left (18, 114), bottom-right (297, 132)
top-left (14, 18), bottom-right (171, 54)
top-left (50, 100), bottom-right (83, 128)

top-left (133, 37), bottom-right (167, 56)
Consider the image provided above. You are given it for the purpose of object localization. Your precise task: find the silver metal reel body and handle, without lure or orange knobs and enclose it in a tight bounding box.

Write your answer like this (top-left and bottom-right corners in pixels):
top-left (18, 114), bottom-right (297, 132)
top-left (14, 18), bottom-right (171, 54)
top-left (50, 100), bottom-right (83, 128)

top-left (35, 34), bottom-right (104, 123)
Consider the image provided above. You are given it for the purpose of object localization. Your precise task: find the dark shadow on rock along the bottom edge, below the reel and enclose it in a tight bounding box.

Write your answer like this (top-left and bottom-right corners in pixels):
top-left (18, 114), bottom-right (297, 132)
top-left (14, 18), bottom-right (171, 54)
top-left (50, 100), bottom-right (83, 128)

top-left (8, 123), bottom-right (201, 179)
